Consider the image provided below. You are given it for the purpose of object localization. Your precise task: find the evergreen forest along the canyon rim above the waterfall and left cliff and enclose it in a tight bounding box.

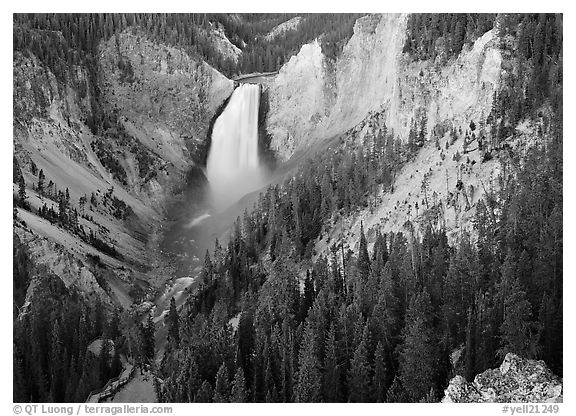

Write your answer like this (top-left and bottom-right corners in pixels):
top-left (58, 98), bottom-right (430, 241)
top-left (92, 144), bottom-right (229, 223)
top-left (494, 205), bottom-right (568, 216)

top-left (14, 13), bottom-right (361, 80)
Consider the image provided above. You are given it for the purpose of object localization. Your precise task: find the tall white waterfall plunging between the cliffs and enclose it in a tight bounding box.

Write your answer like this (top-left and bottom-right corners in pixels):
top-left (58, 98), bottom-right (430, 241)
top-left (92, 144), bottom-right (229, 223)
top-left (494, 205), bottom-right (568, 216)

top-left (206, 84), bottom-right (263, 207)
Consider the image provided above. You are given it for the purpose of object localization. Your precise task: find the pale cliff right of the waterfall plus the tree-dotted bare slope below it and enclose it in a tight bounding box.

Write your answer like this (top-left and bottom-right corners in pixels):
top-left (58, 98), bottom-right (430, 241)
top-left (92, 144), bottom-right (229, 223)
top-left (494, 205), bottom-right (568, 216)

top-left (267, 14), bottom-right (504, 253)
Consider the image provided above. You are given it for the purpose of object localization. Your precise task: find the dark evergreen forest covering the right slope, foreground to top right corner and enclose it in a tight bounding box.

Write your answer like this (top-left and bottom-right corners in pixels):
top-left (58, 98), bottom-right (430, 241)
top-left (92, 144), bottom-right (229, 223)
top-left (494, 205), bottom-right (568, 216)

top-left (157, 15), bottom-right (563, 402)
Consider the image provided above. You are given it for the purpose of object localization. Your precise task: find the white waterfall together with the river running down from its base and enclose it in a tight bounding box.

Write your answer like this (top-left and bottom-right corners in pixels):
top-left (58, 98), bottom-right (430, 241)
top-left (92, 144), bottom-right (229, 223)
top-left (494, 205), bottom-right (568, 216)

top-left (155, 83), bottom-right (268, 326)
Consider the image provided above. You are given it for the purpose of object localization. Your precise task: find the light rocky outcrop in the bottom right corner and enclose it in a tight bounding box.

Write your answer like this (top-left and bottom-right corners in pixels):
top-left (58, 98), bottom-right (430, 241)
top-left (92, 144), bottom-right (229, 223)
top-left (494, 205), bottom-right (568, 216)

top-left (442, 353), bottom-right (562, 403)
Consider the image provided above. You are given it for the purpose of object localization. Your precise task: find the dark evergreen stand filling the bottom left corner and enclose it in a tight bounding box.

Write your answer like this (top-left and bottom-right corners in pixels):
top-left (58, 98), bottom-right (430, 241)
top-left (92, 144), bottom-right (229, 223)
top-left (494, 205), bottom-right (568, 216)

top-left (13, 236), bottom-right (124, 402)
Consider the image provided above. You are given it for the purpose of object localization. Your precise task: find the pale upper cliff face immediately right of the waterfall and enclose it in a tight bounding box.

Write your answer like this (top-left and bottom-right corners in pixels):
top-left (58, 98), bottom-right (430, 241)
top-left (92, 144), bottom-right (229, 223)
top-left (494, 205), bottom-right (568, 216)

top-left (267, 14), bottom-right (502, 159)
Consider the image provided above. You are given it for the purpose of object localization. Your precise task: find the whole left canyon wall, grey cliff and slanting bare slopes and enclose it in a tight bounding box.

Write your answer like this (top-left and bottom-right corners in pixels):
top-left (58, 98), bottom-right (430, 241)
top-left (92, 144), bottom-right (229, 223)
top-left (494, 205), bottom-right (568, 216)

top-left (13, 28), bottom-right (233, 306)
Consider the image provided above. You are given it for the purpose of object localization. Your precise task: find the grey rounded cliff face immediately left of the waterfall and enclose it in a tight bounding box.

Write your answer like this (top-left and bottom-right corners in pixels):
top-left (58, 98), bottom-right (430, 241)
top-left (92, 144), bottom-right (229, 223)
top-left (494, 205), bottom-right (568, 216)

top-left (100, 31), bottom-right (234, 169)
